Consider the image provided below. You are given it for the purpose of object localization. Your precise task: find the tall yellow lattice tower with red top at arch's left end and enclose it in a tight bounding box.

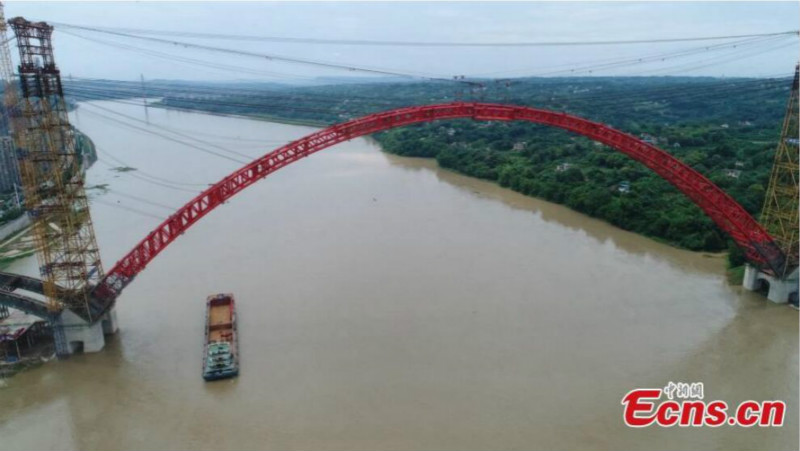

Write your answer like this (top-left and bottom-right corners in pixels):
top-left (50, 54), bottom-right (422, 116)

top-left (5, 17), bottom-right (104, 322)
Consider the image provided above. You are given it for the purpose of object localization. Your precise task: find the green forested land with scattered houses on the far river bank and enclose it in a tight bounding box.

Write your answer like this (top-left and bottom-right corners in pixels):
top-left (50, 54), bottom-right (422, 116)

top-left (147, 77), bottom-right (790, 263)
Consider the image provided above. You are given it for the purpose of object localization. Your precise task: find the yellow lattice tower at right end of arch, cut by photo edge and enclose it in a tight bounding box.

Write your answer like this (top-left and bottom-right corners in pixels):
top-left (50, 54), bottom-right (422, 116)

top-left (761, 65), bottom-right (800, 277)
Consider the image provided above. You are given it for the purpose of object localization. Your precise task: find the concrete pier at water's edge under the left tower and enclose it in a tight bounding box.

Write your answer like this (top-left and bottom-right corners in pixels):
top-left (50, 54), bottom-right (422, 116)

top-left (51, 309), bottom-right (119, 358)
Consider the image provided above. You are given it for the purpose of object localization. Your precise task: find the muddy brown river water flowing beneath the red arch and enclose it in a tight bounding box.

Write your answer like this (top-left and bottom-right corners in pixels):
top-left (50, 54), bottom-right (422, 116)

top-left (0, 102), bottom-right (798, 450)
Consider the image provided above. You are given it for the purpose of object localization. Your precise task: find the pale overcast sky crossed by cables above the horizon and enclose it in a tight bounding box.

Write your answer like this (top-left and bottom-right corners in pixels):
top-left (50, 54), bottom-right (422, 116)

top-left (6, 1), bottom-right (800, 81)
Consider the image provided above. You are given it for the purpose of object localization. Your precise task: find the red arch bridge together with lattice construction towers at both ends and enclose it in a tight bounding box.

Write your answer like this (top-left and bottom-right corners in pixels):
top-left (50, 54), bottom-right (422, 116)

top-left (0, 15), bottom-right (798, 355)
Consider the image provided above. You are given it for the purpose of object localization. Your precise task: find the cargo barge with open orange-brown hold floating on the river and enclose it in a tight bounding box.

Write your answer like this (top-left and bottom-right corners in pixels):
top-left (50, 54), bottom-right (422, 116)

top-left (203, 293), bottom-right (239, 381)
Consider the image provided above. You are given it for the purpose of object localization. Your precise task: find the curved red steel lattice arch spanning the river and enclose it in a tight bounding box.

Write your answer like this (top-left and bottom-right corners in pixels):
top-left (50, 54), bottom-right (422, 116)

top-left (84, 102), bottom-right (784, 318)
